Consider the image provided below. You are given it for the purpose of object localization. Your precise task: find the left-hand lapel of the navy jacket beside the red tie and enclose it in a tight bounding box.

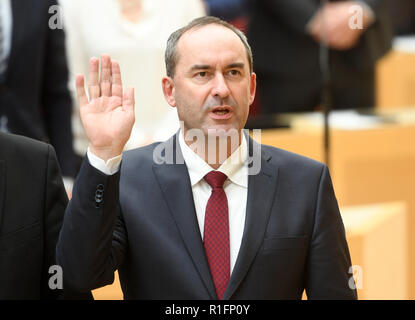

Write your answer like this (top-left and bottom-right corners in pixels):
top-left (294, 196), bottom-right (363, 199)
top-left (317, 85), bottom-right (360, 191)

top-left (153, 135), bottom-right (217, 299)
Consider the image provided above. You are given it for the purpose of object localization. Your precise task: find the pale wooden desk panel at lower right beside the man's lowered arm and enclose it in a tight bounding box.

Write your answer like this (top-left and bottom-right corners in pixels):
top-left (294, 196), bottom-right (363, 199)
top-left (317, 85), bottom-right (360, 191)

top-left (341, 202), bottom-right (408, 300)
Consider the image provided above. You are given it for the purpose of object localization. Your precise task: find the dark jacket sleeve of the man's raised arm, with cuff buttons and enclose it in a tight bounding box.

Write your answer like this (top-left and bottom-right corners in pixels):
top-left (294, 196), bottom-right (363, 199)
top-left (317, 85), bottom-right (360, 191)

top-left (56, 159), bottom-right (127, 292)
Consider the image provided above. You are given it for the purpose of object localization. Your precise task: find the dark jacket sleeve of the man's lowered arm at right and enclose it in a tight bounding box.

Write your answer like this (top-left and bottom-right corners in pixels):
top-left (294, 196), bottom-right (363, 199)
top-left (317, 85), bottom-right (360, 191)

top-left (305, 166), bottom-right (357, 300)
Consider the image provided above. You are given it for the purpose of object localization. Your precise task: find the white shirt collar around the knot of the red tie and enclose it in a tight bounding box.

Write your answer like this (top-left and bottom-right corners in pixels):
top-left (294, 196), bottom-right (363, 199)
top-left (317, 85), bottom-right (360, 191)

top-left (179, 130), bottom-right (248, 188)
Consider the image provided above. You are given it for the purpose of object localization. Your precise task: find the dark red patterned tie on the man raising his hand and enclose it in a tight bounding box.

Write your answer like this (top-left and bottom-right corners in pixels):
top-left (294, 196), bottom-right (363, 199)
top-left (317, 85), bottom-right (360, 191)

top-left (203, 171), bottom-right (230, 300)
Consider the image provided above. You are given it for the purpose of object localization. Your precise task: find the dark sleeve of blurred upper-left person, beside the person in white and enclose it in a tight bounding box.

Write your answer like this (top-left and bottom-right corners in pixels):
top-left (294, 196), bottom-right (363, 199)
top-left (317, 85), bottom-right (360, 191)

top-left (42, 0), bottom-right (76, 177)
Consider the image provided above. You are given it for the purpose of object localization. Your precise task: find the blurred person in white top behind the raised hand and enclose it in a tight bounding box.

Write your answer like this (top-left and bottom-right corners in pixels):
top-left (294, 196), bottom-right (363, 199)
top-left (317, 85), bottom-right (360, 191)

top-left (60, 0), bottom-right (205, 155)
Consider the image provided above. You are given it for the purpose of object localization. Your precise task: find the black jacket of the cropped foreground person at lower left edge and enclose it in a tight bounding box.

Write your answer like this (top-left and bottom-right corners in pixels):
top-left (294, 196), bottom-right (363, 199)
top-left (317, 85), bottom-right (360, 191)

top-left (0, 132), bottom-right (91, 300)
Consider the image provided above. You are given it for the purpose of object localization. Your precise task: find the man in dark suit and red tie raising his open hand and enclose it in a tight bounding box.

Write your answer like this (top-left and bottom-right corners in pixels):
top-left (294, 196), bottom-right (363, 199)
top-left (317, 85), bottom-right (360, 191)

top-left (57, 17), bottom-right (356, 299)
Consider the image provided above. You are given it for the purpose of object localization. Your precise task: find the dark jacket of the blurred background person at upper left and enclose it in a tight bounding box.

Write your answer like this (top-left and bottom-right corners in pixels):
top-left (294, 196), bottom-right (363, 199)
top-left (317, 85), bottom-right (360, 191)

top-left (0, 0), bottom-right (77, 177)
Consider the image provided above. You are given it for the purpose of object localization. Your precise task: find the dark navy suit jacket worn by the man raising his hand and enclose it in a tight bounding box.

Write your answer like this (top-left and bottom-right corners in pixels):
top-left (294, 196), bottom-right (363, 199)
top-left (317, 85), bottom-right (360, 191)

top-left (57, 137), bottom-right (356, 299)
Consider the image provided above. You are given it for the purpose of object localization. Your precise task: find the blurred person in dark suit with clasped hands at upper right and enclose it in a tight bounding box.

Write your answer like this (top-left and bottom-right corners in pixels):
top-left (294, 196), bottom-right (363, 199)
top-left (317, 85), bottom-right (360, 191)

top-left (247, 0), bottom-right (392, 114)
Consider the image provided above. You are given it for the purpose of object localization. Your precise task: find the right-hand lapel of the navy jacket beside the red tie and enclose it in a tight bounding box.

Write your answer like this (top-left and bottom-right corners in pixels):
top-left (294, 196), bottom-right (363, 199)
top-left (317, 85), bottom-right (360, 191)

top-left (224, 139), bottom-right (278, 299)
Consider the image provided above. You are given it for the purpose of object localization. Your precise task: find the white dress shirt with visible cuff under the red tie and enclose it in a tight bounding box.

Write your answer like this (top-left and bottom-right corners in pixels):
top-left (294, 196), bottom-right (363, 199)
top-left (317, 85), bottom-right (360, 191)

top-left (87, 131), bottom-right (248, 273)
